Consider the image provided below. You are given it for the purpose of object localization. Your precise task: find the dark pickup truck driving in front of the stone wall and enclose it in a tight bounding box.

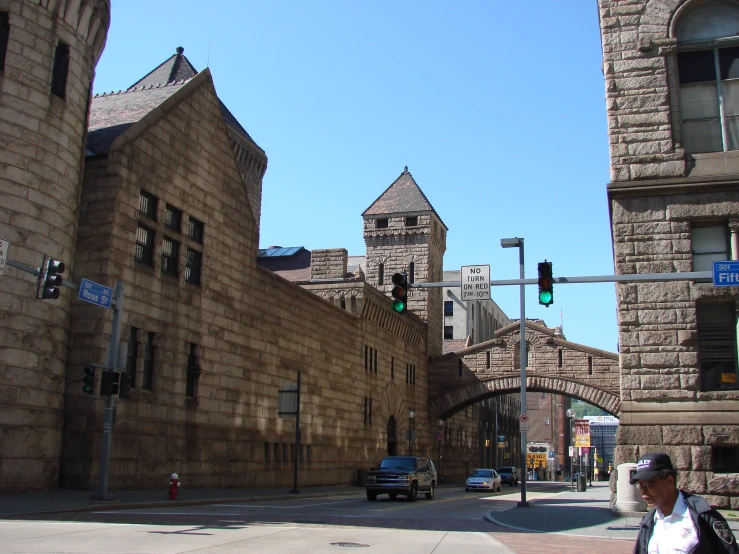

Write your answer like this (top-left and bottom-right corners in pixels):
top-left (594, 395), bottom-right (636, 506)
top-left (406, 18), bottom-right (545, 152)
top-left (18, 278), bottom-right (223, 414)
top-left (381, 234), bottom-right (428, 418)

top-left (366, 456), bottom-right (438, 502)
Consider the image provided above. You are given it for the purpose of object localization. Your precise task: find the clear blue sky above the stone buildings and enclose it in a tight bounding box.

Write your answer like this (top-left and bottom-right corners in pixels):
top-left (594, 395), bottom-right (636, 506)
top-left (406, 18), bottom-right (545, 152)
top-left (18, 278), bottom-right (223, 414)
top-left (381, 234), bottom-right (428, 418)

top-left (95, 0), bottom-right (618, 351)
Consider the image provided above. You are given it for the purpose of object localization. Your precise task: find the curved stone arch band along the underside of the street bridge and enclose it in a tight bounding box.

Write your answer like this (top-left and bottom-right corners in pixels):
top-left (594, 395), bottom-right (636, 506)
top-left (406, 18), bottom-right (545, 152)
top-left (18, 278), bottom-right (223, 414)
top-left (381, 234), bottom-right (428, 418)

top-left (429, 373), bottom-right (621, 420)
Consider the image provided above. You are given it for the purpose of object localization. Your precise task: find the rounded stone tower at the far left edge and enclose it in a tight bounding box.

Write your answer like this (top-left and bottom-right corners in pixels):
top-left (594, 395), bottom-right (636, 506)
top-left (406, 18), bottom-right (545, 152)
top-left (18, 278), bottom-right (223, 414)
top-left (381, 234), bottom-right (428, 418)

top-left (0, 0), bottom-right (110, 491)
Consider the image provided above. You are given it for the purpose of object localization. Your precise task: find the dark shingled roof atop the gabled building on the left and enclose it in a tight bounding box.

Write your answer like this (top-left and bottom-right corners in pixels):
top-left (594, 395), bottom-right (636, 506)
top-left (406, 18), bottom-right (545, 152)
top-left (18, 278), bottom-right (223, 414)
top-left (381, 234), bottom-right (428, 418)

top-left (87, 46), bottom-right (261, 154)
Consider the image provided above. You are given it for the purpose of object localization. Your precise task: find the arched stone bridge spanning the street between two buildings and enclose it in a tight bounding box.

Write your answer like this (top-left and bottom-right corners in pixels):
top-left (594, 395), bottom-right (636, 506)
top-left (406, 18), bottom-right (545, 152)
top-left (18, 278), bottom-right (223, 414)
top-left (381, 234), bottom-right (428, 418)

top-left (429, 321), bottom-right (621, 420)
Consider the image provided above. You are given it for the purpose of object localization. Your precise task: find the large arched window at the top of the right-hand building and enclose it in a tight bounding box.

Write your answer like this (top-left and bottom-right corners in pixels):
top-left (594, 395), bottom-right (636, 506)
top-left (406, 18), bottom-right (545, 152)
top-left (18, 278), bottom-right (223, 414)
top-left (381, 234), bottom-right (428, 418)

top-left (675, 0), bottom-right (739, 154)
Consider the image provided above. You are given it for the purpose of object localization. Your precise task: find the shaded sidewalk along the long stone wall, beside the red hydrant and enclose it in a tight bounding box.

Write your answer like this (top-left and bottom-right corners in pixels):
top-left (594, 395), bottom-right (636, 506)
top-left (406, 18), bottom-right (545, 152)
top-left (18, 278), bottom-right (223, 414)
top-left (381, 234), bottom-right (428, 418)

top-left (0, 485), bottom-right (364, 519)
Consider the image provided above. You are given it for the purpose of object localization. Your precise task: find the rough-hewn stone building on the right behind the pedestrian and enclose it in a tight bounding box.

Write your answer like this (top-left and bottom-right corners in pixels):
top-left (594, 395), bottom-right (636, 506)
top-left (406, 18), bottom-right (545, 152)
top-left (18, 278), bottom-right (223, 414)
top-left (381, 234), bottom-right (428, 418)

top-left (599, 0), bottom-right (739, 502)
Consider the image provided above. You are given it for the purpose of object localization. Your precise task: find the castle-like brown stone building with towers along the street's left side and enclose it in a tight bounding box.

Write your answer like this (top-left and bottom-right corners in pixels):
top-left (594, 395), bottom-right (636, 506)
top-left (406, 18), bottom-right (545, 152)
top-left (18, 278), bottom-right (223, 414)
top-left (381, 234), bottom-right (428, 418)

top-left (0, 0), bottom-right (494, 492)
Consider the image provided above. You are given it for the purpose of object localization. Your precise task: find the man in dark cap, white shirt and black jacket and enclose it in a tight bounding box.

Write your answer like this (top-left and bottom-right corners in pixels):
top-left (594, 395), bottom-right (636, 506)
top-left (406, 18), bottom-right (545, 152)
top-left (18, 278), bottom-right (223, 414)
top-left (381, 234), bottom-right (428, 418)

top-left (629, 452), bottom-right (739, 554)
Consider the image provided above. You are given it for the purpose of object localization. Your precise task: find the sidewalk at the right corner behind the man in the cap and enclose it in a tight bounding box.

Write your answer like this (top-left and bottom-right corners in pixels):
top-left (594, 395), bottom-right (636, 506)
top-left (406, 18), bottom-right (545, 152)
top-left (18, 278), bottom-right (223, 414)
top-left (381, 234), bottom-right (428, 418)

top-left (486, 482), bottom-right (739, 540)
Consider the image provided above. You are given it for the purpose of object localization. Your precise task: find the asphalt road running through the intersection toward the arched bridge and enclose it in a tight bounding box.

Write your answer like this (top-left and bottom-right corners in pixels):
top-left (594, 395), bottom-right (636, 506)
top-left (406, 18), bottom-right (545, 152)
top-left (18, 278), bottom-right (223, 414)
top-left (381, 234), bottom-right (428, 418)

top-left (0, 484), bottom-right (633, 554)
